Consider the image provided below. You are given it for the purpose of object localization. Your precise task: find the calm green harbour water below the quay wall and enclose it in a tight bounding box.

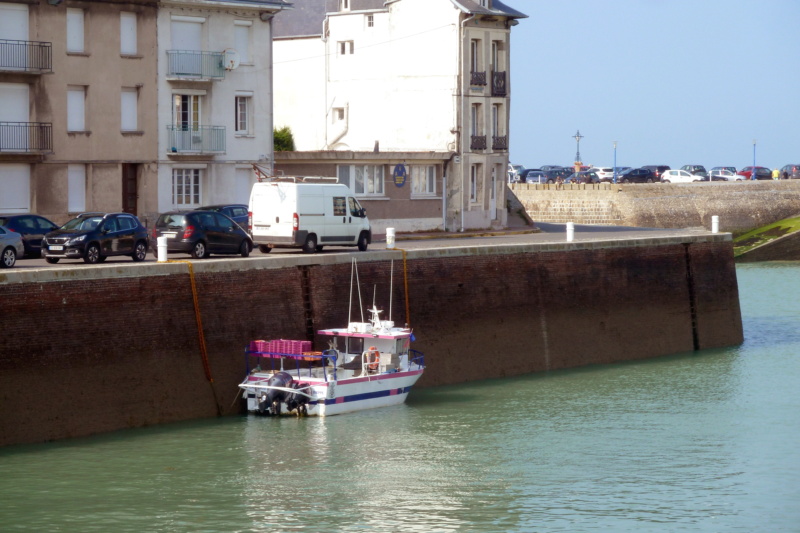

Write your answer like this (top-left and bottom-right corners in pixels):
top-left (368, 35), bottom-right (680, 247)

top-left (0, 263), bottom-right (800, 532)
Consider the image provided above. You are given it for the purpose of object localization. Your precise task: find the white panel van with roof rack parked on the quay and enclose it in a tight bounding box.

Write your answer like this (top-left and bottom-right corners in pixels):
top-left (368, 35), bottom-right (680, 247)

top-left (249, 181), bottom-right (372, 254)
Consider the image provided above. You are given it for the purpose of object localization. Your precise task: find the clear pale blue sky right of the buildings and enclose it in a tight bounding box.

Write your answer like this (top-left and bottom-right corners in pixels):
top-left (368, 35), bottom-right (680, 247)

top-left (504, 0), bottom-right (800, 169)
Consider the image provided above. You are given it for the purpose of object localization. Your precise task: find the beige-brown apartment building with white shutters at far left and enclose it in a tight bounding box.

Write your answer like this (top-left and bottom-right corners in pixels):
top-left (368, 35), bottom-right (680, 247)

top-left (0, 0), bottom-right (157, 222)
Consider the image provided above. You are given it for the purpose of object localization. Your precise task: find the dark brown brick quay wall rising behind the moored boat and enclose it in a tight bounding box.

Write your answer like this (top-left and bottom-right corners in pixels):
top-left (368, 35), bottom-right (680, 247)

top-left (0, 234), bottom-right (743, 446)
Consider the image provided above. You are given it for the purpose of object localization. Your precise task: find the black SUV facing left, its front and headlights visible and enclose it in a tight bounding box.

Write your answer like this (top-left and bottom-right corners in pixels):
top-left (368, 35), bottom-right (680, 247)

top-left (42, 213), bottom-right (147, 264)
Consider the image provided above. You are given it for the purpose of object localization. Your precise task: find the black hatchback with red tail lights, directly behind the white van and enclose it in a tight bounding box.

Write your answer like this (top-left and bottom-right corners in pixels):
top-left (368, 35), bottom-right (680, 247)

top-left (150, 210), bottom-right (253, 259)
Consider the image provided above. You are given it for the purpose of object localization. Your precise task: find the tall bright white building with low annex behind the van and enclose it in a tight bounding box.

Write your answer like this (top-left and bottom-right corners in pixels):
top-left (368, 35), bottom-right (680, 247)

top-left (274, 0), bottom-right (526, 233)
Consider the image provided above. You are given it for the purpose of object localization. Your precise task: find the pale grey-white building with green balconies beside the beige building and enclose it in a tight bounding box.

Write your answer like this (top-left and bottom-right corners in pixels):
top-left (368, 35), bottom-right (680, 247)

top-left (158, 0), bottom-right (290, 218)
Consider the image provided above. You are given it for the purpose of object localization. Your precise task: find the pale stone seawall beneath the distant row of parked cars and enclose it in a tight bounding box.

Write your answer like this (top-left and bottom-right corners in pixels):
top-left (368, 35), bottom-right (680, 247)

top-left (510, 180), bottom-right (800, 233)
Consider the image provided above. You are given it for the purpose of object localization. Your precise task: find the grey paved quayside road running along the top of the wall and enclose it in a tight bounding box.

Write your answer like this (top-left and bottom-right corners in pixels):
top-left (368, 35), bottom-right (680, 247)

top-left (9, 223), bottom-right (708, 269)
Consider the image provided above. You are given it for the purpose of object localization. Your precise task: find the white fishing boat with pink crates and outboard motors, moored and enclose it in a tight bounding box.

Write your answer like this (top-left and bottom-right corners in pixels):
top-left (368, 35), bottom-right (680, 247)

top-left (239, 264), bottom-right (425, 416)
